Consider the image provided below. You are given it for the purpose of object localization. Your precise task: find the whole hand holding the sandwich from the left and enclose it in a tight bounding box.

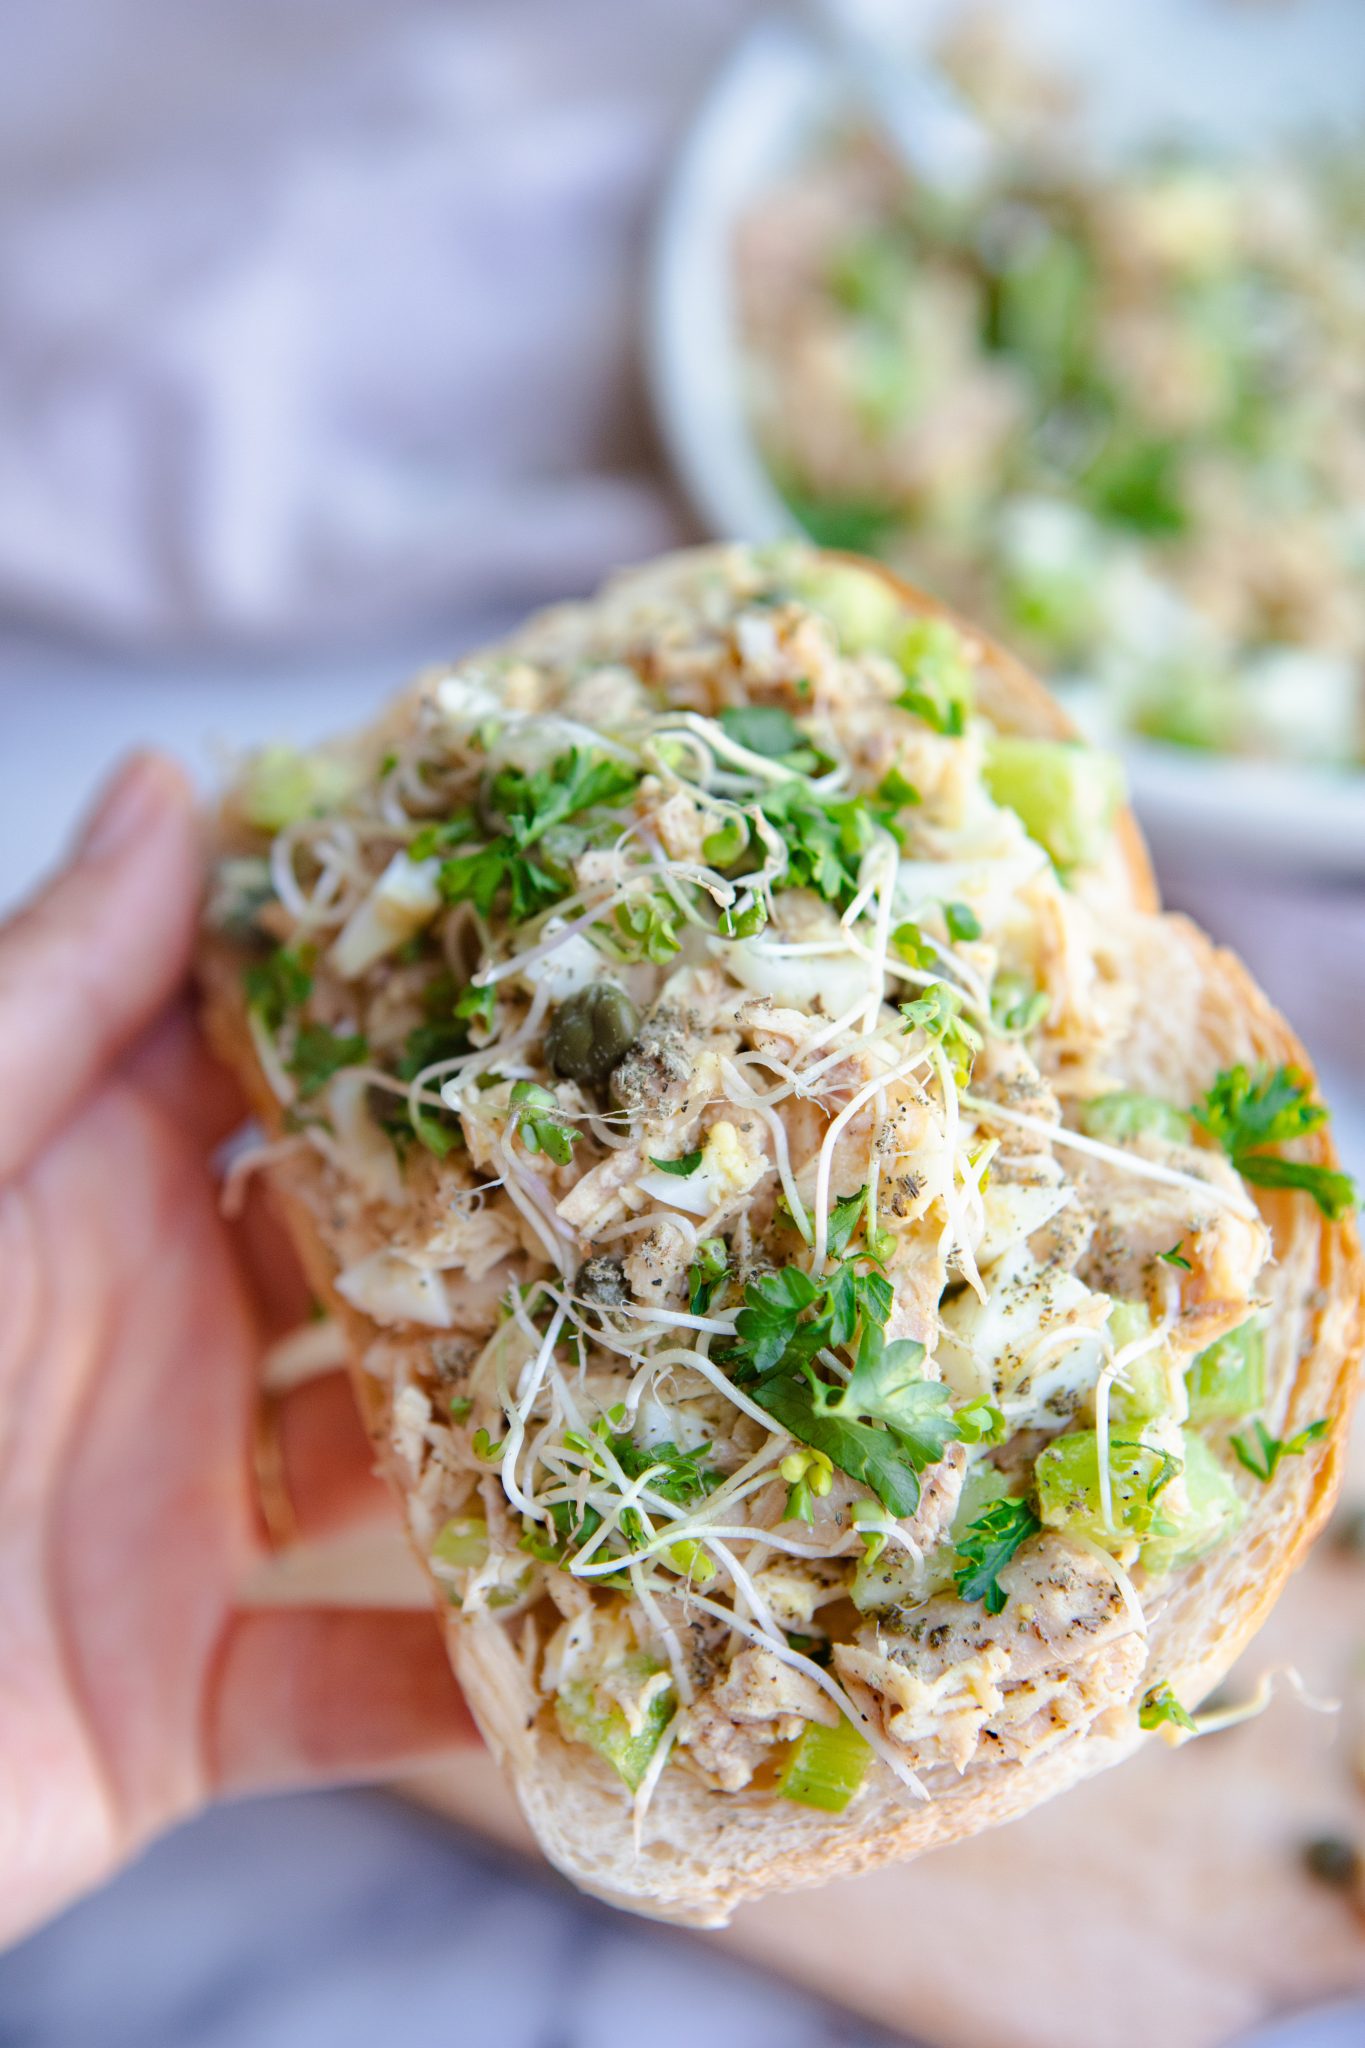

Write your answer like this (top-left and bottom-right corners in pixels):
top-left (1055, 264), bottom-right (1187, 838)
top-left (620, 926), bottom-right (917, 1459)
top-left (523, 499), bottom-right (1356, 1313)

top-left (0, 756), bottom-right (471, 1942)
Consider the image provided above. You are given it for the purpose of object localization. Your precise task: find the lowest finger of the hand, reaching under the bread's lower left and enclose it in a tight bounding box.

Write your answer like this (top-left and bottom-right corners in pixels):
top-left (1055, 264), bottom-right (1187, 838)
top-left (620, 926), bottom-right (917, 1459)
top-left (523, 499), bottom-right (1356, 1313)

top-left (207, 1608), bottom-right (475, 1792)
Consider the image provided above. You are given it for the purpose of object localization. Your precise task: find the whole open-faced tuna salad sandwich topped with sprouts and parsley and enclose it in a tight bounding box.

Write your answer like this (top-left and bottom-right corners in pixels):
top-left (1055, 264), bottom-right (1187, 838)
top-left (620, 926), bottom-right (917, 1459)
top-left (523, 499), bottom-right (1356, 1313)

top-left (203, 549), bottom-right (1359, 1923)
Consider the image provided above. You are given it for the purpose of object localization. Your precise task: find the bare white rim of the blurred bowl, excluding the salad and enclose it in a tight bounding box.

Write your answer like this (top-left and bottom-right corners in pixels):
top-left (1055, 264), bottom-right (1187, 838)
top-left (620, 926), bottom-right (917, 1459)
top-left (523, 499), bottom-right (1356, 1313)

top-left (647, 0), bottom-right (1365, 877)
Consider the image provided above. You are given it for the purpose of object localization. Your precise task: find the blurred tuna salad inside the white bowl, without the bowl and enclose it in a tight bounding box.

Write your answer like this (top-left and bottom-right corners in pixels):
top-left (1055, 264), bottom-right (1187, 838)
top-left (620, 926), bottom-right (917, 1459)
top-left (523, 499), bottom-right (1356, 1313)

top-left (735, 27), bottom-right (1365, 766)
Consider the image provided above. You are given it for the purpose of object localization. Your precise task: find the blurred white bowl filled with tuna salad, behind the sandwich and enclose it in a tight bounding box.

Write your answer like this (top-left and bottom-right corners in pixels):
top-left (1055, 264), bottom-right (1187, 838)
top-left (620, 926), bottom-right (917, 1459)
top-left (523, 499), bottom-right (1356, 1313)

top-left (651, 0), bottom-right (1365, 874)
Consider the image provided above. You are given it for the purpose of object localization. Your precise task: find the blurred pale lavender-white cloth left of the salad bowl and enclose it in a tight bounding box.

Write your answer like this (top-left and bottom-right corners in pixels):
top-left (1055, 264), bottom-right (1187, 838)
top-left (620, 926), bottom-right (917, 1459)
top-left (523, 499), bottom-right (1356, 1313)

top-left (0, 0), bottom-right (747, 643)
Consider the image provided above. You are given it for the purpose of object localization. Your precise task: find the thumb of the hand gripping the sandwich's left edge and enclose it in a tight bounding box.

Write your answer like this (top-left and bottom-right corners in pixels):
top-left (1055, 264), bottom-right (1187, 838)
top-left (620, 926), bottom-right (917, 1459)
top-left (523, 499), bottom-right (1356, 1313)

top-left (0, 754), bottom-right (201, 1180)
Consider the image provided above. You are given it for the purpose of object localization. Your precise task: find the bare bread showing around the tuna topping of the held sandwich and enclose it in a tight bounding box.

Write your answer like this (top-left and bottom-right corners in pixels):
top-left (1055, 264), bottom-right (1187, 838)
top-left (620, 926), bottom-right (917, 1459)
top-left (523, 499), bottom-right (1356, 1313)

top-left (201, 555), bottom-right (1361, 1925)
